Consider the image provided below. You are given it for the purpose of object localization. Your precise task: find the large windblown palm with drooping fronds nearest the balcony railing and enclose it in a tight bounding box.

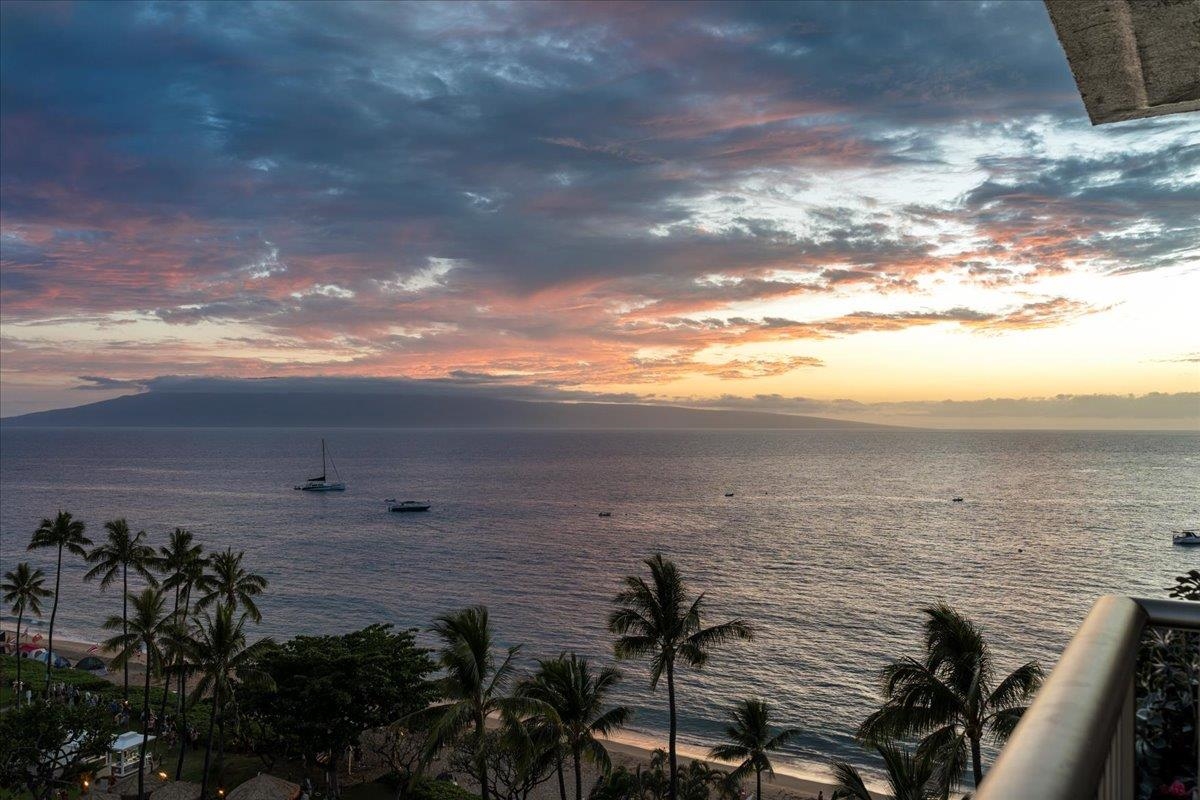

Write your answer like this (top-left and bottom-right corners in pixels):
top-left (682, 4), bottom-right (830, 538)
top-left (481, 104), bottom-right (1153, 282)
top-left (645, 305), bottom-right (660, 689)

top-left (858, 602), bottom-right (1042, 787)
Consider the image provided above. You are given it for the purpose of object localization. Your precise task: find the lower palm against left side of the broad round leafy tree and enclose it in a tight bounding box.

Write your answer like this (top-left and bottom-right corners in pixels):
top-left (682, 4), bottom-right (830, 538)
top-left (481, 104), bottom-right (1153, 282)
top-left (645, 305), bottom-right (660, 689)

top-left (191, 603), bottom-right (272, 800)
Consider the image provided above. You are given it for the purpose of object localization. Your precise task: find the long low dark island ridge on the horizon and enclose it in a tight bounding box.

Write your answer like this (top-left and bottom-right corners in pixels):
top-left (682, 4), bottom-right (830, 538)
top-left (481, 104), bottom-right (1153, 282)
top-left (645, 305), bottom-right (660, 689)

top-left (0, 391), bottom-right (893, 429)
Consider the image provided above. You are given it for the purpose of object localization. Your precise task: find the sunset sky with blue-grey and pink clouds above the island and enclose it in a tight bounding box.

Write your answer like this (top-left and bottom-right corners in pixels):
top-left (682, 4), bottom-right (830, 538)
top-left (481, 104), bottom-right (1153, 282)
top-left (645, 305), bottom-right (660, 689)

top-left (0, 2), bottom-right (1200, 427)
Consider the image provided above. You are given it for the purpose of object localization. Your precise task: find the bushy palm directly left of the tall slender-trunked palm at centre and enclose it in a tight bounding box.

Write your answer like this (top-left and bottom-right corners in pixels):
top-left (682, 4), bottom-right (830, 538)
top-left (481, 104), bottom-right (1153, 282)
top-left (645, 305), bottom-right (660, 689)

top-left (518, 652), bottom-right (632, 800)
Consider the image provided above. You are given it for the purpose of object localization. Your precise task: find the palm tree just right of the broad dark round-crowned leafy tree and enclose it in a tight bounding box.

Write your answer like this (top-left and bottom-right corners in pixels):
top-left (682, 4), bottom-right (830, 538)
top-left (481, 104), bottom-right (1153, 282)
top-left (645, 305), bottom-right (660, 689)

top-left (427, 606), bottom-right (521, 800)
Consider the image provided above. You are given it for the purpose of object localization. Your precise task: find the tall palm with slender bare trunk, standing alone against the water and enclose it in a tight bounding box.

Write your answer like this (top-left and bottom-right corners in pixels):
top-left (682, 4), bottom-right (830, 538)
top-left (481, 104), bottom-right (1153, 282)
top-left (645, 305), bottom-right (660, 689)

top-left (608, 553), bottom-right (754, 800)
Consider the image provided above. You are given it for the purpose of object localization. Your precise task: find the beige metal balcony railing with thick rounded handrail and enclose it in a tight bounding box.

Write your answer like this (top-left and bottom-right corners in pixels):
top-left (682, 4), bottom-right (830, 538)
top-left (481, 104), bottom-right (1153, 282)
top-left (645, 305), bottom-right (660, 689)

top-left (976, 596), bottom-right (1200, 800)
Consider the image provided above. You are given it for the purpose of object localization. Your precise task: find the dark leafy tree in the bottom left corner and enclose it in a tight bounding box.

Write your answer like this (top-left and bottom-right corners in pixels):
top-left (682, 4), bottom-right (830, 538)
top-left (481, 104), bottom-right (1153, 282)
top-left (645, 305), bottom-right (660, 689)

top-left (0, 700), bottom-right (115, 800)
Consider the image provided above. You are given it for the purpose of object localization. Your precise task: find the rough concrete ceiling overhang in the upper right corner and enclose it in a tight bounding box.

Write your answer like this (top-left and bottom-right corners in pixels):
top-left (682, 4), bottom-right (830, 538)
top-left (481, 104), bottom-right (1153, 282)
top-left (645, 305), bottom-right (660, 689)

top-left (1045, 0), bottom-right (1200, 125)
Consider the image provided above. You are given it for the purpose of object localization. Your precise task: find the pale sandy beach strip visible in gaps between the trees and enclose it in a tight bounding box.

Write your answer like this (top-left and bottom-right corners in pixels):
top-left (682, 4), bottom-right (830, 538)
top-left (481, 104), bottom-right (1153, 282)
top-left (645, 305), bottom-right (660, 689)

top-left (9, 633), bottom-right (833, 800)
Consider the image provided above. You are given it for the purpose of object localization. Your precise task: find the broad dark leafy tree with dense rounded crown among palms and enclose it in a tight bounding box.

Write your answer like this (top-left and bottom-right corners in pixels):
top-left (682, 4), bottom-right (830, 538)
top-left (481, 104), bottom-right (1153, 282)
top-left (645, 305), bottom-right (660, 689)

top-left (240, 625), bottom-right (433, 796)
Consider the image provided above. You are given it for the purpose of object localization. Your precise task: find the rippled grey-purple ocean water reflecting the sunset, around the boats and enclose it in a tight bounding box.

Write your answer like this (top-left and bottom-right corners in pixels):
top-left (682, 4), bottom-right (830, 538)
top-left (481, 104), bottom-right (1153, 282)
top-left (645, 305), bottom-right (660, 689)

top-left (0, 429), bottom-right (1200, 771)
